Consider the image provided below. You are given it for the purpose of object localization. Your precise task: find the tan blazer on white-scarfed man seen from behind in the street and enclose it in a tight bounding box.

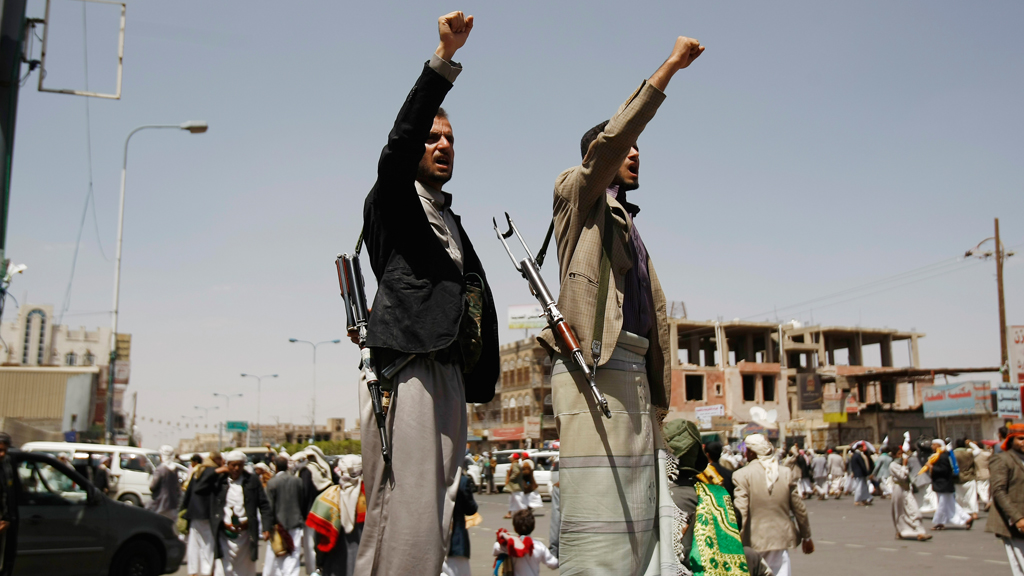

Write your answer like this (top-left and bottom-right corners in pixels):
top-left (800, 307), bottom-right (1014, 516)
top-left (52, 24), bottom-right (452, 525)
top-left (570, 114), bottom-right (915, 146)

top-left (732, 460), bottom-right (811, 552)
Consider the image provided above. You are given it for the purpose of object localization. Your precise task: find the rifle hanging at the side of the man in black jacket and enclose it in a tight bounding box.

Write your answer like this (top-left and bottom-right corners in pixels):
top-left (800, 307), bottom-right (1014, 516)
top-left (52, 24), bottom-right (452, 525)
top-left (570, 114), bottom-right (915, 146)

top-left (335, 249), bottom-right (415, 465)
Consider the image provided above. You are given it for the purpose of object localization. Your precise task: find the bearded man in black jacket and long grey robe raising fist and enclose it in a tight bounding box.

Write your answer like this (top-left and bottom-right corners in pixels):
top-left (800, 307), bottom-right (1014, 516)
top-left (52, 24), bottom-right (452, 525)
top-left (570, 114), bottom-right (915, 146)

top-left (355, 12), bottom-right (499, 575)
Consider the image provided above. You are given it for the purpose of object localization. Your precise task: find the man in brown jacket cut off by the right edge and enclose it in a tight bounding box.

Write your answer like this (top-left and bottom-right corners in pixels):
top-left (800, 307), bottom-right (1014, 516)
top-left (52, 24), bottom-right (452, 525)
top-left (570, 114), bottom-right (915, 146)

top-left (985, 424), bottom-right (1024, 574)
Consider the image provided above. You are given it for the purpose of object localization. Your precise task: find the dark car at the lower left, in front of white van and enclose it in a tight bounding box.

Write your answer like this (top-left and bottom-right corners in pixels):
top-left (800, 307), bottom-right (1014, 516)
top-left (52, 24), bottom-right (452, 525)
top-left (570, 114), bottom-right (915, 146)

top-left (8, 451), bottom-right (185, 576)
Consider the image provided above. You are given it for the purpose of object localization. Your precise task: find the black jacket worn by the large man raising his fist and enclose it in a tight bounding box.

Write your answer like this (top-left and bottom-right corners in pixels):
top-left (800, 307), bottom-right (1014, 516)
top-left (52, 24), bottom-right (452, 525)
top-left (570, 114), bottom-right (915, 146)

top-left (362, 66), bottom-right (499, 403)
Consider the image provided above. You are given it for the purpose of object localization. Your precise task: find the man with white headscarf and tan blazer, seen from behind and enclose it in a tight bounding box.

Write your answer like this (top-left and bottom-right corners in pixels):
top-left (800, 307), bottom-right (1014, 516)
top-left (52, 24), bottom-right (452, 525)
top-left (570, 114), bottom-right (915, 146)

top-left (732, 434), bottom-right (814, 576)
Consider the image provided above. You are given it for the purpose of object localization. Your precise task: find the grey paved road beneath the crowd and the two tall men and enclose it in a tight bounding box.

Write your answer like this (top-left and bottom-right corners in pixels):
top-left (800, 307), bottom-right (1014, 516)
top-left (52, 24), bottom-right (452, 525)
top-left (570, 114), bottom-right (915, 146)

top-left (169, 487), bottom-right (1010, 576)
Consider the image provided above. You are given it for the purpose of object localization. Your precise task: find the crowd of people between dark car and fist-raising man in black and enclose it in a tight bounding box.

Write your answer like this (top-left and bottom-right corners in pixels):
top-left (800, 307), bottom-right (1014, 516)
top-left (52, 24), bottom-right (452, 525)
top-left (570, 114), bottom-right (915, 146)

top-left (167, 445), bottom-right (366, 576)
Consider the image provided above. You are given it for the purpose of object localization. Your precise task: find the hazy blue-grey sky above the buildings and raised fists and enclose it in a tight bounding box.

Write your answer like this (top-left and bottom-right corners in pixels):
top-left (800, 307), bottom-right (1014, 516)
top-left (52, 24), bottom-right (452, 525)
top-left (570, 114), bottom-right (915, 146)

top-left (5, 0), bottom-right (1024, 447)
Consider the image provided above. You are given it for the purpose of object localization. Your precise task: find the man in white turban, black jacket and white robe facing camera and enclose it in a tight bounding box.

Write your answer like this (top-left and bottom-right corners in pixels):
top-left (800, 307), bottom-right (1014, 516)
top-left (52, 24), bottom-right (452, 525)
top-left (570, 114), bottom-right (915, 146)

top-left (210, 450), bottom-right (274, 576)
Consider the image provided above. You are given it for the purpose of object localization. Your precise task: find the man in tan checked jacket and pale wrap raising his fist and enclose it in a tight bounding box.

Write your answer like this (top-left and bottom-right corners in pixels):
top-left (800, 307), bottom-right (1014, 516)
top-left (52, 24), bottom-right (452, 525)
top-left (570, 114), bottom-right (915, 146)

top-left (541, 37), bottom-right (703, 576)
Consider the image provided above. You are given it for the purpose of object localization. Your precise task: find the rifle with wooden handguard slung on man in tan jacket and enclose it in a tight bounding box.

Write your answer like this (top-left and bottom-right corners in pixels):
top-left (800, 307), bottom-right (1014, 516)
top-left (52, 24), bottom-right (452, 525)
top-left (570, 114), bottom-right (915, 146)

top-left (490, 212), bottom-right (611, 418)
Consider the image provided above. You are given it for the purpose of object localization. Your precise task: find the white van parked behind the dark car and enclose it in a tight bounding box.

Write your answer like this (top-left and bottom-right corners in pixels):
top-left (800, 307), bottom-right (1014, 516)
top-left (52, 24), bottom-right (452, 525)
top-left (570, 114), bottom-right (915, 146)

top-left (22, 442), bottom-right (160, 506)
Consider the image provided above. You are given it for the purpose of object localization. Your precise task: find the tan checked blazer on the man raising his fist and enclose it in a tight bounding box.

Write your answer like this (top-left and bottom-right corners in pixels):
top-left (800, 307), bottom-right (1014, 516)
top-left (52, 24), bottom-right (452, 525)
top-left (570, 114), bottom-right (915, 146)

top-left (540, 82), bottom-right (672, 410)
